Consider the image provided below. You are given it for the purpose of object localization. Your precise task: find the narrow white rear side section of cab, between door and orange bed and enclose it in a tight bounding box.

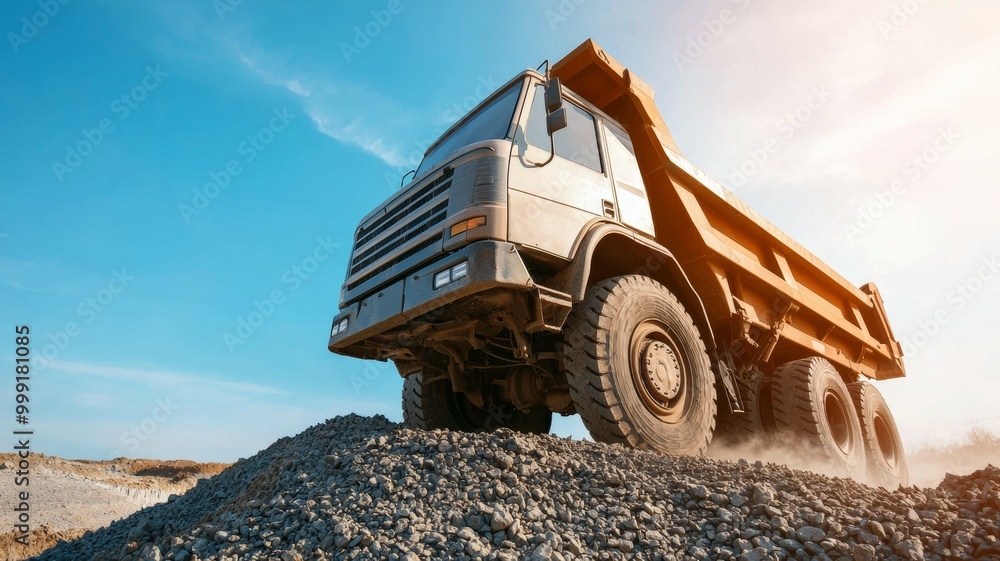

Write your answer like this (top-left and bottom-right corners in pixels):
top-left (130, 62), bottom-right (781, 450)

top-left (602, 121), bottom-right (654, 236)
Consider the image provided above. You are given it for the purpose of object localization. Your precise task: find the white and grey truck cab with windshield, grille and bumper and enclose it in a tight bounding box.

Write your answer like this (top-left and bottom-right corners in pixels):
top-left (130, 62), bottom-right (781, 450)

top-left (329, 70), bottom-right (654, 361)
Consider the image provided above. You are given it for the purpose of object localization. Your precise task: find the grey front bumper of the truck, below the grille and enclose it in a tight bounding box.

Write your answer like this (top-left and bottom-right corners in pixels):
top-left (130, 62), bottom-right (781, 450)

top-left (327, 241), bottom-right (534, 358)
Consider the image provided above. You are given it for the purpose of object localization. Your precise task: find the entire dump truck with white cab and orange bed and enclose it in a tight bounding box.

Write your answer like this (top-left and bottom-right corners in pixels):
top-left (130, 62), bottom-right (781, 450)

top-left (328, 40), bottom-right (907, 485)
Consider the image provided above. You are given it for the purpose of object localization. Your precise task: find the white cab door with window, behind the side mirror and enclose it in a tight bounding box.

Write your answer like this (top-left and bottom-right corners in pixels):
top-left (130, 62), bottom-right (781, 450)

top-left (508, 85), bottom-right (617, 257)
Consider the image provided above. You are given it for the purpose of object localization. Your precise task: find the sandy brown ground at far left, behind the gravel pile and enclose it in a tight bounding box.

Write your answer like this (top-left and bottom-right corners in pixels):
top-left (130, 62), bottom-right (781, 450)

top-left (0, 454), bottom-right (228, 561)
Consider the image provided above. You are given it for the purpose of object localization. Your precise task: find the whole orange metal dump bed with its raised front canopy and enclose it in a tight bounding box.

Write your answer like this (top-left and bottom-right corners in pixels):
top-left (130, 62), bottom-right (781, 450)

top-left (552, 40), bottom-right (905, 379)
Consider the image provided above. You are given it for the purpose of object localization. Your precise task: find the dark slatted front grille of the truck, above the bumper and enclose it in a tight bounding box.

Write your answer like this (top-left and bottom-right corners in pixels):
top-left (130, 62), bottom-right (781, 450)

top-left (348, 170), bottom-right (451, 289)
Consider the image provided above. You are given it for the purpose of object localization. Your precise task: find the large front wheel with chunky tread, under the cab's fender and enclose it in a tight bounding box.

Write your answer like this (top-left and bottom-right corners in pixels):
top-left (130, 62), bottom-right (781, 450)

top-left (563, 275), bottom-right (716, 455)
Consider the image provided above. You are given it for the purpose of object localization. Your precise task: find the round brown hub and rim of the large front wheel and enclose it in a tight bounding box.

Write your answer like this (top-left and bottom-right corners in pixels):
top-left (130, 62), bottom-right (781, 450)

top-left (629, 321), bottom-right (691, 422)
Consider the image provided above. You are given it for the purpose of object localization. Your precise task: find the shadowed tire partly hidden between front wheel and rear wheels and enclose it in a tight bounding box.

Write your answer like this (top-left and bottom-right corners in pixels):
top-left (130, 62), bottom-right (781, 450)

top-left (714, 372), bottom-right (775, 445)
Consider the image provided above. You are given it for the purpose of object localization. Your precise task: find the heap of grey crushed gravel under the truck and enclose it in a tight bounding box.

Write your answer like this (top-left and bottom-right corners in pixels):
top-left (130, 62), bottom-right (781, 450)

top-left (29, 415), bottom-right (1000, 561)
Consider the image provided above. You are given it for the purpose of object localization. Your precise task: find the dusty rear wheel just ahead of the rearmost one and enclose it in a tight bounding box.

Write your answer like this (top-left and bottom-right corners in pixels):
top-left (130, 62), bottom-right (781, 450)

top-left (771, 357), bottom-right (865, 479)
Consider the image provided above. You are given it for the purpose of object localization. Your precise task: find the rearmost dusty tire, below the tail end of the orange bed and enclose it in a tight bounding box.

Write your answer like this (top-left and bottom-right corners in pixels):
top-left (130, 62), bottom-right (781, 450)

top-left (847, 382), bottom-right (910, 490)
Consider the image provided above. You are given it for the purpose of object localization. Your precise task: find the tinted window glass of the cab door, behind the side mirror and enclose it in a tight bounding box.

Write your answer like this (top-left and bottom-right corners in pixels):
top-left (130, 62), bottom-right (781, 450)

top-left (525, 85), bottom-right (604, 173)
